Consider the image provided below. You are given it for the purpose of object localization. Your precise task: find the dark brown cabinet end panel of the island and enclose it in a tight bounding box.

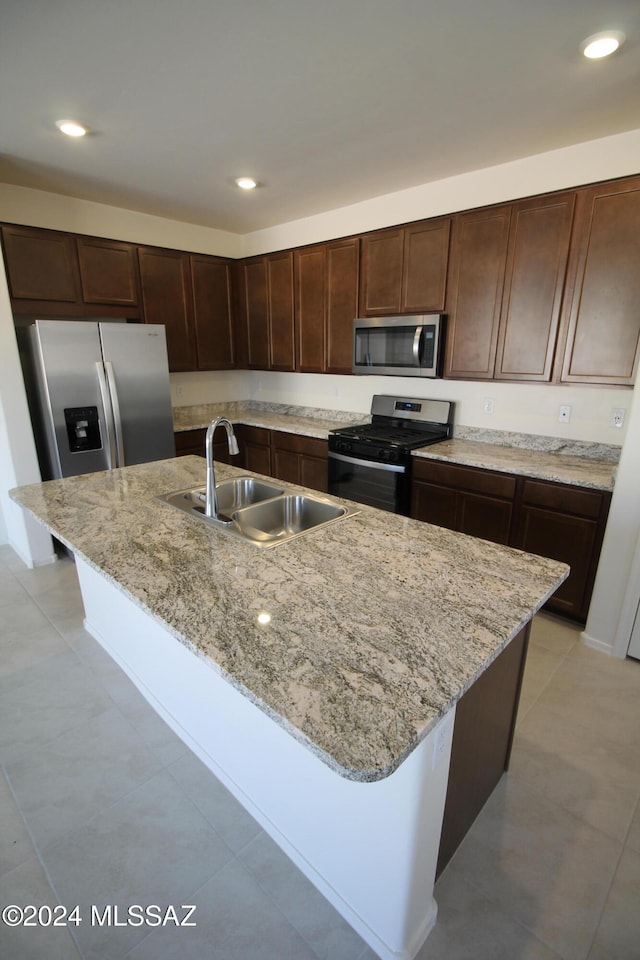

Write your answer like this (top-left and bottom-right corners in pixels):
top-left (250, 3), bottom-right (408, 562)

top-left (436, 623), bottom-right (531, 877)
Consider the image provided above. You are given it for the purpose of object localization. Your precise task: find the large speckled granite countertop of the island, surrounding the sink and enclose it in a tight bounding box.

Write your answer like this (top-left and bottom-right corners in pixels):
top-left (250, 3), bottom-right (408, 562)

top-left (11, 457), bottom-right (568, 781)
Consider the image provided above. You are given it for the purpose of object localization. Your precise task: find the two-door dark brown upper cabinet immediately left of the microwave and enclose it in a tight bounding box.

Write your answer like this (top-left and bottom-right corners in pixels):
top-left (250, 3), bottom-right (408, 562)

top-left (294, 237), bottom-right (360, 373)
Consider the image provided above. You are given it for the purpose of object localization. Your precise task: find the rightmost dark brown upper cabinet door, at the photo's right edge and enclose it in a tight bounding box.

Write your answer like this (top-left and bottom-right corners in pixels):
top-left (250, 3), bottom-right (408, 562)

top-left (561, 177), bottom-right (640, 385)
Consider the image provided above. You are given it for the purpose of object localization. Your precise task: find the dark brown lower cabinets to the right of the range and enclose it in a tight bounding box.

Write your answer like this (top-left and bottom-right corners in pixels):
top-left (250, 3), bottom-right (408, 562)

top-left (411, 458), bottom-right (611, 623)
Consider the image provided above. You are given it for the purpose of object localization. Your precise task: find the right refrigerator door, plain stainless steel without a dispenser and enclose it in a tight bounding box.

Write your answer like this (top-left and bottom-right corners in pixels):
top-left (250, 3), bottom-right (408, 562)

top-left (100, 323), bottom-right (175, 466)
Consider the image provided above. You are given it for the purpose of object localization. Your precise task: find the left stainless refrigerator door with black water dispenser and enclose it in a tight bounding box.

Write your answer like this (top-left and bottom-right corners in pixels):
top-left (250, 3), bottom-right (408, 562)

top-left (29, 320), bottom-right (111, 479)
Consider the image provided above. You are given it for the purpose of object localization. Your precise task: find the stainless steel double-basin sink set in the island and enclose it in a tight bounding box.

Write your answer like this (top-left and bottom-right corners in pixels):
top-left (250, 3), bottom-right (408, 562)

top-left (158, 477), bottom-right (358, 547)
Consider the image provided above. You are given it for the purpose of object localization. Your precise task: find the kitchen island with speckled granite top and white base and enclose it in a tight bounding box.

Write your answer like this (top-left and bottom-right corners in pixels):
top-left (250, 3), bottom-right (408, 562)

top-left (12, 457), bottom-right (568, 958)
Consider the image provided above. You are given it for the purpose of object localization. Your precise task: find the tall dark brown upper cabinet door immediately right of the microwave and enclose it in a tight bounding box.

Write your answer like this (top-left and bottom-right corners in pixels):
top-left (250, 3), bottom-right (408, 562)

top-left (445, 207), bottom-right (511, 380)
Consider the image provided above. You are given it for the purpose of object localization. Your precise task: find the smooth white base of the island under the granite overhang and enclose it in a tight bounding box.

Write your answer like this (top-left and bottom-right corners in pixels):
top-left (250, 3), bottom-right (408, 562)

top-left (77, 558), bottom-right (455, 960)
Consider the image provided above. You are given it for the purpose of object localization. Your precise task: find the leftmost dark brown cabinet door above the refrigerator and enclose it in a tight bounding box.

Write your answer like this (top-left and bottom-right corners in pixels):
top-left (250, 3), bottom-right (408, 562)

top-left (2, 226), bottom-right (82, 304)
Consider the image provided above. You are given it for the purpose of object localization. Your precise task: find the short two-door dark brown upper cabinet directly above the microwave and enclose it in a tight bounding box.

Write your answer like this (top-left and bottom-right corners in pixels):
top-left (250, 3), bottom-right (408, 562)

top-left (359, 217), bottom-right (451, 317)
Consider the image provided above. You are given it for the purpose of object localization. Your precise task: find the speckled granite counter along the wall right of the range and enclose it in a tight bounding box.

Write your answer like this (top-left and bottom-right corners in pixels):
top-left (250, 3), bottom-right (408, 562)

top-left (413, 439), bottom-right (616, 490)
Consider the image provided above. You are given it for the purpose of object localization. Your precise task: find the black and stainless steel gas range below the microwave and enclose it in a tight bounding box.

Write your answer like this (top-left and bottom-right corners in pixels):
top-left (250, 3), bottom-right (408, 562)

top-left (329, 394), bottom-right (454, 516)
